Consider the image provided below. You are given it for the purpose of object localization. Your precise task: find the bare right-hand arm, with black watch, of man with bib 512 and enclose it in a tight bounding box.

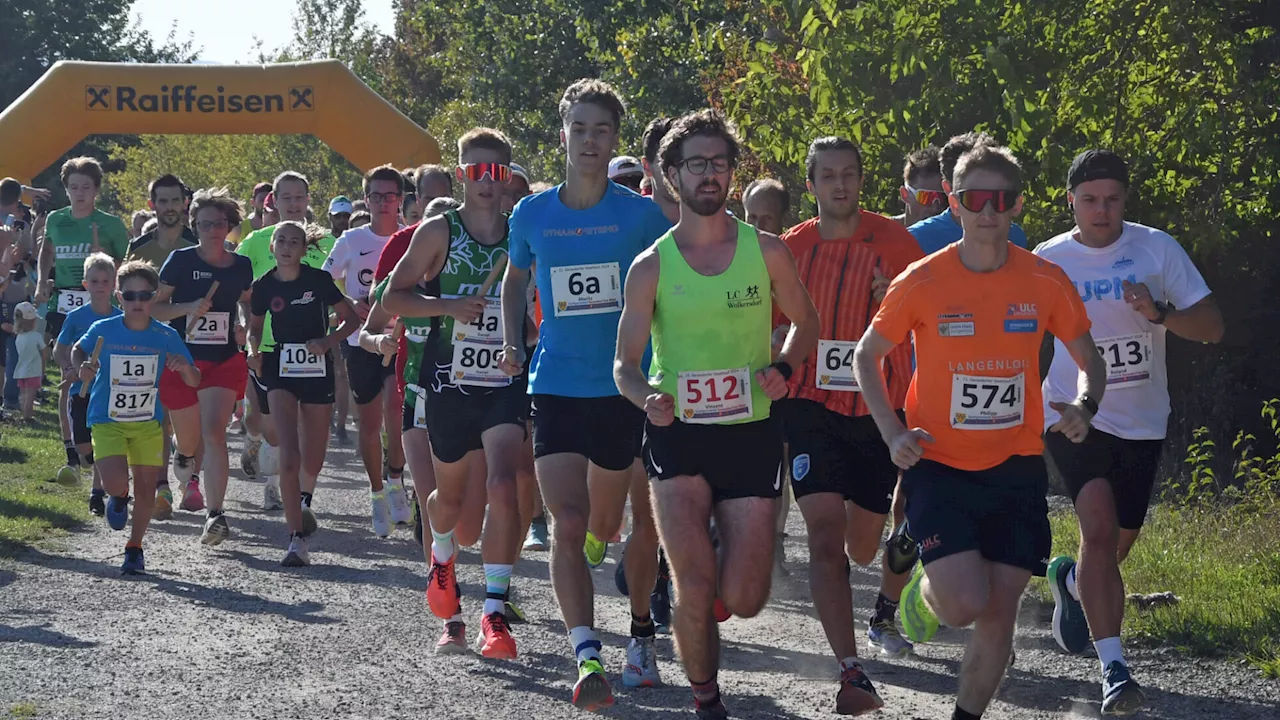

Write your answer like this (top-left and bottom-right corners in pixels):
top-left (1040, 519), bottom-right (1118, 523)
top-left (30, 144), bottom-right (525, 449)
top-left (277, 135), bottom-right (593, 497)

top-left (756, 233), bottom-right (818, 400)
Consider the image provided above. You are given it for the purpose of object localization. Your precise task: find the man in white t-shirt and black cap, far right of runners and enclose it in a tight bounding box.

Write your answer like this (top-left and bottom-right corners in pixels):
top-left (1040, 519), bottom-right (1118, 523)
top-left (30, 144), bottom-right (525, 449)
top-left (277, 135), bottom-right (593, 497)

top-left (1036, 150), bottom-right (1222, 715)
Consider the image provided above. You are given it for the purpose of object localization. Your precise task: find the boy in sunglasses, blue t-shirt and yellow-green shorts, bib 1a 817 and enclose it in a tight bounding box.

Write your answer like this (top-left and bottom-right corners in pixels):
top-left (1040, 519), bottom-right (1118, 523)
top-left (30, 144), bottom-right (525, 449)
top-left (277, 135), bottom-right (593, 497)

top-left (72, 260), bottom-right (200, 575)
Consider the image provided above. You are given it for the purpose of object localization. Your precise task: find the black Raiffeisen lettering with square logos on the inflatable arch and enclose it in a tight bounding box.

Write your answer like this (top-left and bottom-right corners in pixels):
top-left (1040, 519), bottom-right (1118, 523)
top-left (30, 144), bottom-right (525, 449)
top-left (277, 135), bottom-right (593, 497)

top-left (84, 85), bottom-right (315, 114)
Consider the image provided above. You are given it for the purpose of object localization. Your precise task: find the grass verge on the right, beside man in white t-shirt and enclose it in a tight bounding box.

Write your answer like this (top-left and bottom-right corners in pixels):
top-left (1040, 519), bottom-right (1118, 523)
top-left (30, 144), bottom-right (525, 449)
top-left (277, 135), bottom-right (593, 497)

top-left (1036, 498), bottom-right (1280, 679)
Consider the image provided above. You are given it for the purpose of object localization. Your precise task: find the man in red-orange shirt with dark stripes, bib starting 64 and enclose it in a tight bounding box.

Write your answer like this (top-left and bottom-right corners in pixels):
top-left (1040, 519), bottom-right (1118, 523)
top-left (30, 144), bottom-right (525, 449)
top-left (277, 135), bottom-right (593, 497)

top-left (777, 137), bottom-right (924, 676)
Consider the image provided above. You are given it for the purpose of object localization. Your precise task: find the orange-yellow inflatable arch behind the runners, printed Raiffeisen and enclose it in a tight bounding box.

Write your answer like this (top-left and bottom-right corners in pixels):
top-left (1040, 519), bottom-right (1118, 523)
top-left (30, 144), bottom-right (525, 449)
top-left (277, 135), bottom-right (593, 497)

top-left (0, 60), bottom-right (440, 182)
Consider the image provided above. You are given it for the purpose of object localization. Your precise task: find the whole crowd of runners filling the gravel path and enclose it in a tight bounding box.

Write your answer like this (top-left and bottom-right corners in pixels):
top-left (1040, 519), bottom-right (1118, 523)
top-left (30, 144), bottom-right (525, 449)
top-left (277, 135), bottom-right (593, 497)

top-left (0, 79), bottom-right (1222, 720)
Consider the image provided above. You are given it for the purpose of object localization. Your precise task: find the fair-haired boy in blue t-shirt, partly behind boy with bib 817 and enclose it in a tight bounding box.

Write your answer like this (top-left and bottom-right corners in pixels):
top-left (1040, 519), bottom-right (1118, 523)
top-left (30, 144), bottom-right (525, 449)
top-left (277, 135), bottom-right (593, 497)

top-left (54, 252), bottom-right (120, 509)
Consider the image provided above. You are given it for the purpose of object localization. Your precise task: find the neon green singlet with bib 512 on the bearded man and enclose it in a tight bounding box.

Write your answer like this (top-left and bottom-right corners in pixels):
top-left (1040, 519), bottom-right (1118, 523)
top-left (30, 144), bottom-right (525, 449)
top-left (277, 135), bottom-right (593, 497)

top-left (650, 220), bottom-right (772, 424)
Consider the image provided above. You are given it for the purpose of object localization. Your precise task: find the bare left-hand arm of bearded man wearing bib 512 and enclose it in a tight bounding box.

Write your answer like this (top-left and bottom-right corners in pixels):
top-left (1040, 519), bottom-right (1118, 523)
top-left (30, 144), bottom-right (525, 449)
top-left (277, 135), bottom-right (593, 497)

top-left (613, 249), bottom-right (676, 428)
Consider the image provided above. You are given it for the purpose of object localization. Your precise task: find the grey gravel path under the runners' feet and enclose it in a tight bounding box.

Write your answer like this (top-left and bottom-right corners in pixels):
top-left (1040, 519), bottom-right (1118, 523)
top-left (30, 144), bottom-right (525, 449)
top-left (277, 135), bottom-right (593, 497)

top-left (0, 427), bottom-right (1280, 720)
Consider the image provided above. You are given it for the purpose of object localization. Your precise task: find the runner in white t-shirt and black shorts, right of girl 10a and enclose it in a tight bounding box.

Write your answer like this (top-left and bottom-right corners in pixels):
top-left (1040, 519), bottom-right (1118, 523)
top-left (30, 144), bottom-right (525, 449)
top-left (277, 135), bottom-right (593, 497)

top-left (324, 165), bottom-right (413, 537)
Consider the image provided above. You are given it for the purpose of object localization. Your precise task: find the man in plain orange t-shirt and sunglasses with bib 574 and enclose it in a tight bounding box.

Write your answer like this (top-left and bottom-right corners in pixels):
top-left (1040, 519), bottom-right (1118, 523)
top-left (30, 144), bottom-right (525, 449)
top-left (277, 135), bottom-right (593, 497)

top-left (854, 146), bottom-right (1106, 720)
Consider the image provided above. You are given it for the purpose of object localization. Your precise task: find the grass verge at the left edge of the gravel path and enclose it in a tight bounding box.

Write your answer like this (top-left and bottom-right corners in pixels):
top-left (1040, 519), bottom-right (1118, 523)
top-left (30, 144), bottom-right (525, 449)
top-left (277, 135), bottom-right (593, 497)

top-left (0, 387), bottom-right (90, 556)
